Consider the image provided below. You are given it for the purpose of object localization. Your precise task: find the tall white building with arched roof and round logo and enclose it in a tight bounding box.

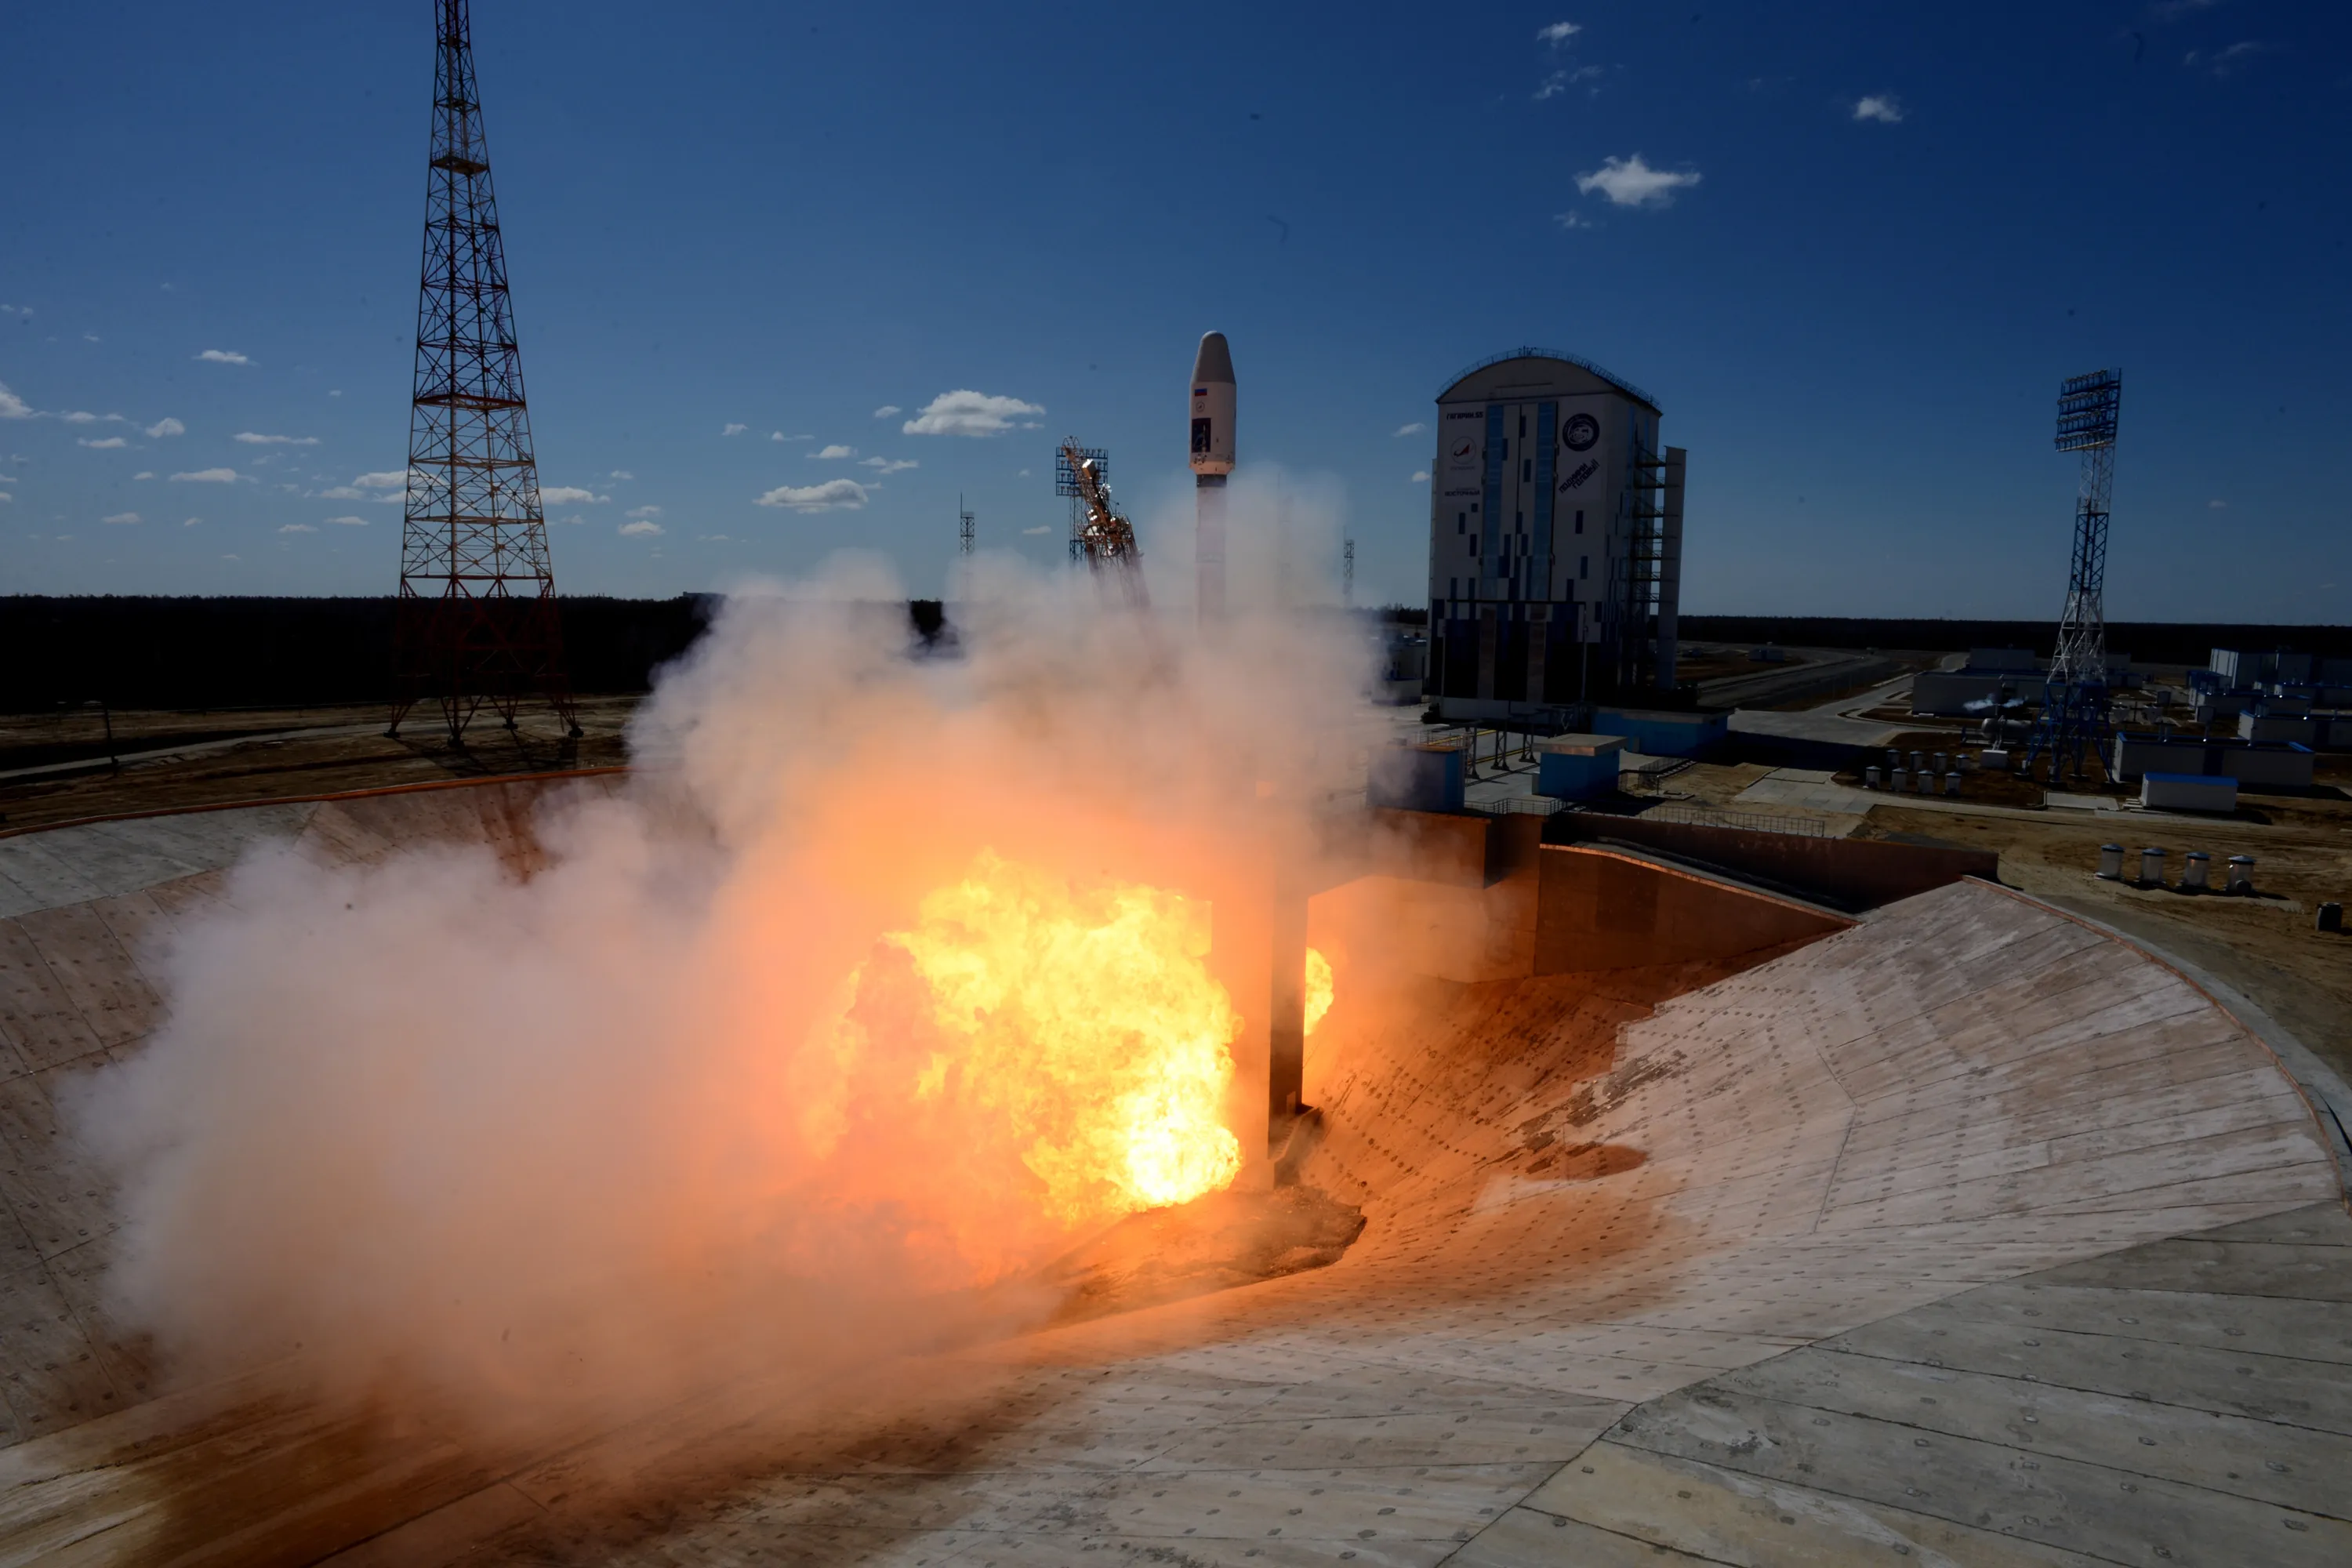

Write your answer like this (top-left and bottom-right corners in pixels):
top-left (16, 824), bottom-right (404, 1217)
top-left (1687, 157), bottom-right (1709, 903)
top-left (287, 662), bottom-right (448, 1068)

top-left (1428, 348), bottom-right (1684, 720)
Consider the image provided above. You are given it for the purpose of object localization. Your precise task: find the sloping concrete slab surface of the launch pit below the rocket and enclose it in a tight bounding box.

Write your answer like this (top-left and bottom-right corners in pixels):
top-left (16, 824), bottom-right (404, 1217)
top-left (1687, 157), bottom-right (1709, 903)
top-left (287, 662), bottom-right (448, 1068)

top-left (0, 785), bottom-right (2352, 1568)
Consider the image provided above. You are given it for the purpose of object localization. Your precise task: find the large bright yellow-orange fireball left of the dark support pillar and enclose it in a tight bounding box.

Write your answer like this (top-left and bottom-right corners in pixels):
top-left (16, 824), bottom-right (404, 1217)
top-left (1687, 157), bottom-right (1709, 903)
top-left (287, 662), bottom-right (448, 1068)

top-left (856, 851), bottom-right (1242, 1227)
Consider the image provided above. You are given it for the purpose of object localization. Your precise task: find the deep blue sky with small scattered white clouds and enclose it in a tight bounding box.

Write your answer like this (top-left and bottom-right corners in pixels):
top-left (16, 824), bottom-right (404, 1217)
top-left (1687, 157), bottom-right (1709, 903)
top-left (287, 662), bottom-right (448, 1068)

top-left (0, 0), bottom-right (2352, 621)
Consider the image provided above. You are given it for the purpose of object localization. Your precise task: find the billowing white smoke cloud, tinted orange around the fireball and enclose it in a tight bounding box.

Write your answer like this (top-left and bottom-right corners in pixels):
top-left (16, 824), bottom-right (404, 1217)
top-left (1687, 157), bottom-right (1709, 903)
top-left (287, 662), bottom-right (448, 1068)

top-left (75, 561), bottom-right (1359, 1436)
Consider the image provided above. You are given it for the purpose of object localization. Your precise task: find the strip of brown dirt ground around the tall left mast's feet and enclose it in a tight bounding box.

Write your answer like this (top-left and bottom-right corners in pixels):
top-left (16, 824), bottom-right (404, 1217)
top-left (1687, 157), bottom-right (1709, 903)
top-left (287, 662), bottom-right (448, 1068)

top-left (0, 696), bottom-right (640, 832)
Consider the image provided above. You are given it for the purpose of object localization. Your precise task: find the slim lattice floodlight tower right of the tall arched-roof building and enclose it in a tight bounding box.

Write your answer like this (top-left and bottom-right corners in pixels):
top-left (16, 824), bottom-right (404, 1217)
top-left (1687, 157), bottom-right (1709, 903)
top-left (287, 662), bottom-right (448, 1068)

top-left (2025, 369), bottom-right (2124, 783)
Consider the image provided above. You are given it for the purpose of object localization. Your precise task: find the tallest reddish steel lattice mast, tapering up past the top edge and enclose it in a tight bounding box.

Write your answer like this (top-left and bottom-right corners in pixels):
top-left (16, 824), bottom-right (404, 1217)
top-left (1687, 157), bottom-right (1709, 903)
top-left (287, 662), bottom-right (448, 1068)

top-left (390, 0), bottom-right (581, 743)
